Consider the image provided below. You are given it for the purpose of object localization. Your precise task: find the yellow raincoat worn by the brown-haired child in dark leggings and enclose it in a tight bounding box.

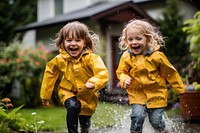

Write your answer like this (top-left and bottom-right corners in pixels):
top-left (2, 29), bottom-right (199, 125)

top-left (40, 50), bottom-right (108, 115)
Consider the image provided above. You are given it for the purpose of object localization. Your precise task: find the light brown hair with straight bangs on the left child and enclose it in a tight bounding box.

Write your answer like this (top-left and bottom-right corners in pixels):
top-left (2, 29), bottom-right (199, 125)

top-left (53, 21), bottom-right (99, 52)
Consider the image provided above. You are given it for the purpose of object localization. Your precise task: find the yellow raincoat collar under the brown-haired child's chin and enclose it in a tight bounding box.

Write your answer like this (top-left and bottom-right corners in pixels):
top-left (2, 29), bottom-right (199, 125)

top-left (59, 48), bottom-right (90, 60)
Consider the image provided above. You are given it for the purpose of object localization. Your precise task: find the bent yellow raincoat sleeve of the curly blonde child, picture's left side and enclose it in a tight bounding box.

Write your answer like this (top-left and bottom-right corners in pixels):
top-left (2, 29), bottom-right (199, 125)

top-left (116, 53), bottom-right (131, 88)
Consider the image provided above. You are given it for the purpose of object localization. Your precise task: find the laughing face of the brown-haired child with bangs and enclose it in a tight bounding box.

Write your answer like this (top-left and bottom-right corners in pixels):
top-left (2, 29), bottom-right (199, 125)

top-left (64, 38), bottom-right (85, 58)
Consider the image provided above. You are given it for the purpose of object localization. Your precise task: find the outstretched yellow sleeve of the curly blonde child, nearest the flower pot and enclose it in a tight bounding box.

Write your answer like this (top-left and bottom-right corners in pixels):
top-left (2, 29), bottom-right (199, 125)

top-left (160, 52), bottom-right (185, 94)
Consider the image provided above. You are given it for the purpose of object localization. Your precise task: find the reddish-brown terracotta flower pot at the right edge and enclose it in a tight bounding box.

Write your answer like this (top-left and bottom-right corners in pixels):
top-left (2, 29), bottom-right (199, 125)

top-left (180, 91), bottom-right (200, 121)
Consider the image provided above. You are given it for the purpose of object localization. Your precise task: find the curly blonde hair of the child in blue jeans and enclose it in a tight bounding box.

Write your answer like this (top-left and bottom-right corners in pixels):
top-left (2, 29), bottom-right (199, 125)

top-left (119, 19), bottom-right (165, 51)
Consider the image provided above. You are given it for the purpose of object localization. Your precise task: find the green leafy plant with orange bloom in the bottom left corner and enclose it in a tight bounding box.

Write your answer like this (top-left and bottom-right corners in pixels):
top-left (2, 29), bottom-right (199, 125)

top-left (0, 98), bottom-right (44, 133)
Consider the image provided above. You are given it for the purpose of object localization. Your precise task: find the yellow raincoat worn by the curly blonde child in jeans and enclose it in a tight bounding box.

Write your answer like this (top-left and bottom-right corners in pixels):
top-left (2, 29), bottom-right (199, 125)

top-left (116, 50), bottom-right (185, 108)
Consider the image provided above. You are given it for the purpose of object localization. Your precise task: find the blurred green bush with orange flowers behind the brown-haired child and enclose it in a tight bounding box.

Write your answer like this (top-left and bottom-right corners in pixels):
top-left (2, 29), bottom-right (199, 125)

top-left (0, 42), bottom-right (48, 107)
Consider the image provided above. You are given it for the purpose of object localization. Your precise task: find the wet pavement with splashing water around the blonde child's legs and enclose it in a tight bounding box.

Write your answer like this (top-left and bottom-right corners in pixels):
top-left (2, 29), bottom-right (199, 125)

top-left (90, 116), bottom-right (200, 133)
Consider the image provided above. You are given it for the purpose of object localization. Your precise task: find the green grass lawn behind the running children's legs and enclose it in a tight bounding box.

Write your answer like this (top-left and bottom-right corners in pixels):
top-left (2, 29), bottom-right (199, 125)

top-left (19, 102), bottom-right (179, 132)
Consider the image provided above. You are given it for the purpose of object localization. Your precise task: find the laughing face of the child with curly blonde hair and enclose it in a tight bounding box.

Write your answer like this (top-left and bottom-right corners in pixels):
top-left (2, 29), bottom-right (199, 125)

top-left (126, 29), bottom-right (148, 55)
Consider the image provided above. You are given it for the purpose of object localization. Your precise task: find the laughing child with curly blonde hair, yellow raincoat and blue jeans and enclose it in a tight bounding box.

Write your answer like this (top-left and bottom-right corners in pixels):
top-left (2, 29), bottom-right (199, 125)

top-left (116, 20), bottom-right (185, 133)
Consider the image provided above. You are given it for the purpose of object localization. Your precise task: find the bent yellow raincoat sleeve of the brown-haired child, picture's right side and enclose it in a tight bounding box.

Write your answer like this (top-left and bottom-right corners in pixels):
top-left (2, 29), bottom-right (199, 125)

top-left (88, 55), bottom-right (109, 91)
